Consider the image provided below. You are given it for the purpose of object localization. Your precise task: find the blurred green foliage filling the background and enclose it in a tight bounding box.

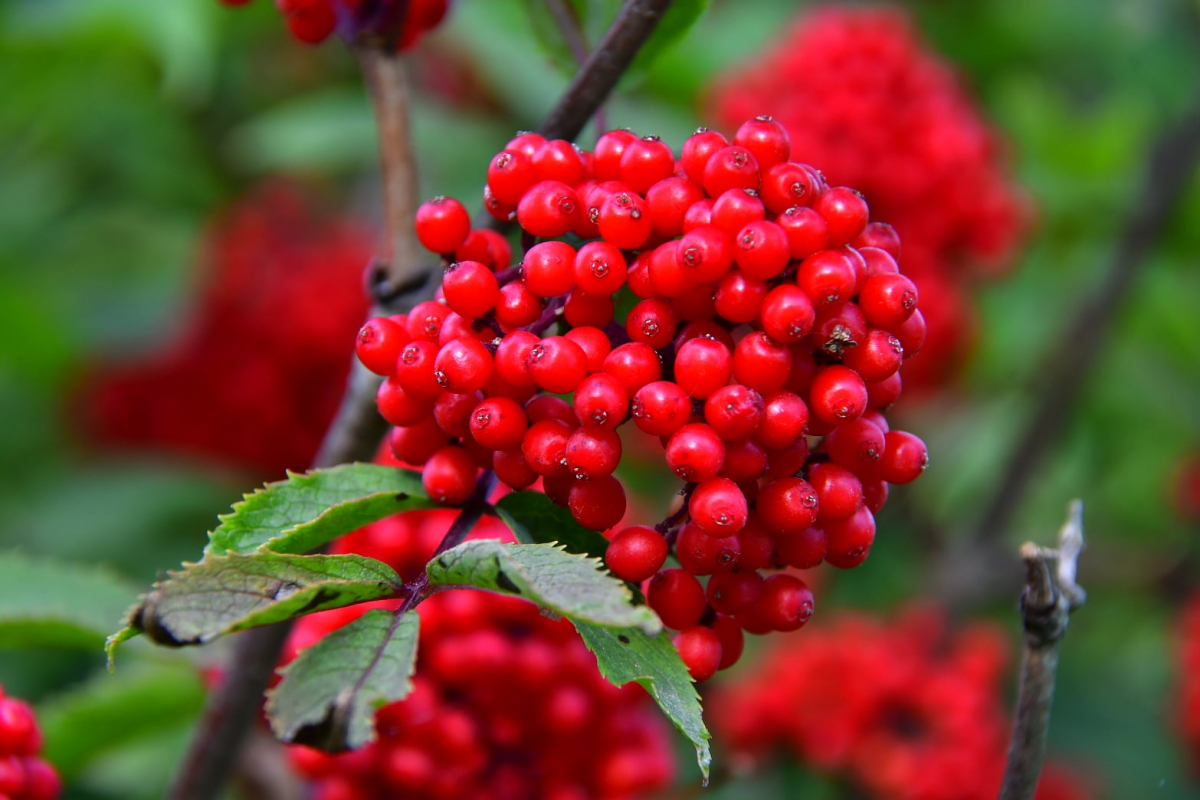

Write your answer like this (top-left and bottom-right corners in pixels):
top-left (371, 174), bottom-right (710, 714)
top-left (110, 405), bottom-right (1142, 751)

top-left (0, 0), bottom-right (1200, 800)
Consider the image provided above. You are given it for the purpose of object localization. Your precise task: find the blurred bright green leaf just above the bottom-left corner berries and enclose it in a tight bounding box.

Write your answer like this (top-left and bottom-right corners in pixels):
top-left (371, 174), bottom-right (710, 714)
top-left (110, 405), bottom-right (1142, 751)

top-left (37, 662), bottom-right (204, 781)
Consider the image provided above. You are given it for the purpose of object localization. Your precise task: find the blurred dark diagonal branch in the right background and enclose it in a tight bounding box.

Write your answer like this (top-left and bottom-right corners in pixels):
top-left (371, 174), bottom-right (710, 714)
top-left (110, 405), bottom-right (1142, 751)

top-left (935, 92), bottom-right (1200, 606)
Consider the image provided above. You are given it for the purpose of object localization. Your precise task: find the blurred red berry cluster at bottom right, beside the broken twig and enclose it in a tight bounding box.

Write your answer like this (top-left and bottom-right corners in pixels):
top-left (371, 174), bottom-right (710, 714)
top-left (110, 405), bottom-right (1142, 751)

top-left (707, 609), bottom-right (1091, 800)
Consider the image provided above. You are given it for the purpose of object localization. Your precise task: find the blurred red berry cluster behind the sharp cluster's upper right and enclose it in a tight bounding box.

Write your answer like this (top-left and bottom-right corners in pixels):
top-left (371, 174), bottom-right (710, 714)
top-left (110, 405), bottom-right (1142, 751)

top-left (712, 6), bottom-right (1028, 385)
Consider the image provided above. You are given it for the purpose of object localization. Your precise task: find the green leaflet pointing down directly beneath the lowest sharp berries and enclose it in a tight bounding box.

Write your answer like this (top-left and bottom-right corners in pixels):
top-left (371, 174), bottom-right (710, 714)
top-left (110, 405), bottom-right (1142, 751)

top-left (571, 620), bottom-right (713, 786)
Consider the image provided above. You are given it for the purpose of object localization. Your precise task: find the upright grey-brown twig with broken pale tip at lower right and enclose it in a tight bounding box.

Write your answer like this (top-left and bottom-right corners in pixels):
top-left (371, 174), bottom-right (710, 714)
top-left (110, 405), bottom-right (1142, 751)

top-left (1000, 500), bottom-right (1086, 800)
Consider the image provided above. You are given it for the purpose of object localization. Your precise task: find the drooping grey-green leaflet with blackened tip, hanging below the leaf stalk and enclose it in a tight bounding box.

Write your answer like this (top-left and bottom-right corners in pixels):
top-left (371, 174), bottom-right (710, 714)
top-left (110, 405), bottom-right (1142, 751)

top-left (266, 609), bottom-right (420, 752)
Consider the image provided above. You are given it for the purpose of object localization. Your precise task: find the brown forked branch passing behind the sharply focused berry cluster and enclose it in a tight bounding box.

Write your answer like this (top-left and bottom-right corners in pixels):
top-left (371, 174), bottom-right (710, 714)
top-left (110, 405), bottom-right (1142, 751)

top-left (167, 0), bottom-right (671, 800)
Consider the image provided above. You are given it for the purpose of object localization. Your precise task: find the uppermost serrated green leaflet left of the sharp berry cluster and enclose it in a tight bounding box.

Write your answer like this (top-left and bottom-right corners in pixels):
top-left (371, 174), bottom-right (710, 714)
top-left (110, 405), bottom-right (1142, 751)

top-left (205, 464), bottom-right (433, 557)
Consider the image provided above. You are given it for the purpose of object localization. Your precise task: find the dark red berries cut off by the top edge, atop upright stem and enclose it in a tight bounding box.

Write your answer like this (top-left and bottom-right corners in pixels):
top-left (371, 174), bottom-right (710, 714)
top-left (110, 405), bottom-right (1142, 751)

top-left (220, 0), bottom-right (450, 50)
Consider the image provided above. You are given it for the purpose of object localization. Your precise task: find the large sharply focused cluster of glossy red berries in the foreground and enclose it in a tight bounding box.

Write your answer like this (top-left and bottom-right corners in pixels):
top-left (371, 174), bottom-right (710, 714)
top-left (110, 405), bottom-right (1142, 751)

top-left (358, 116), bottom-right (928, 680)
